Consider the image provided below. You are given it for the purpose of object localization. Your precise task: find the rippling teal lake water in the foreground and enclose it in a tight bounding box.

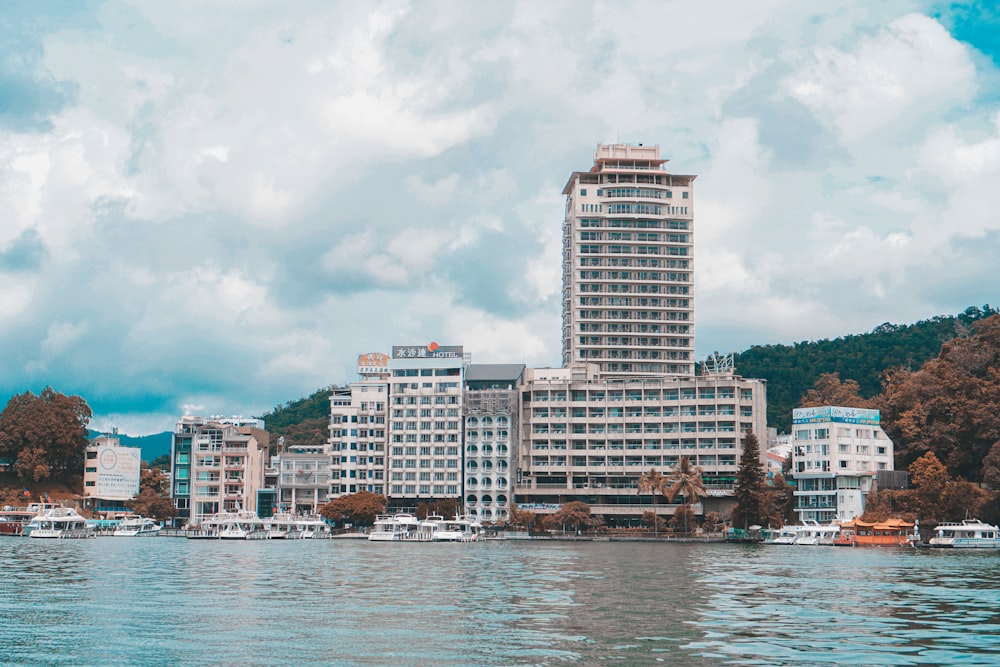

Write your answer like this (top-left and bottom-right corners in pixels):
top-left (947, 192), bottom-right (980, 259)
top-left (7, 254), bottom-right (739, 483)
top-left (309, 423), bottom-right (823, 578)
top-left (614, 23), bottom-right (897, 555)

top-left (0, 537), bottom-right (1000, 666)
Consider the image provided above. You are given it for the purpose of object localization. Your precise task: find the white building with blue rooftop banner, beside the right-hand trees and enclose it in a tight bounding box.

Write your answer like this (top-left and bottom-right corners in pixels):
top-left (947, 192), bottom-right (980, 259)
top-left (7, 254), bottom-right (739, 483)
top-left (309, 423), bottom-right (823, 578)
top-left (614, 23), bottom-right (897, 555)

top-left (792, 406), bottom-right (893, 523)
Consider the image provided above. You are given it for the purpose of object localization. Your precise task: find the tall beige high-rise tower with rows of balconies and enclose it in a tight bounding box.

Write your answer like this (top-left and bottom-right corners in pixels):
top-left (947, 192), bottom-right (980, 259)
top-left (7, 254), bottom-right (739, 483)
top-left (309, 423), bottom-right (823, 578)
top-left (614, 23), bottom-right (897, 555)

top-left (563, 144), bottom-right (696, 377)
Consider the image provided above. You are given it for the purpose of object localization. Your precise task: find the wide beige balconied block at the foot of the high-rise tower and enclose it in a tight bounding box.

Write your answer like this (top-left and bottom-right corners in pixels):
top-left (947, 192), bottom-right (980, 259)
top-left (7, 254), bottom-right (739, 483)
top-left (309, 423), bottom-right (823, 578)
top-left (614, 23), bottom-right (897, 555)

top-left (516, 364), bottom-right (766, 525)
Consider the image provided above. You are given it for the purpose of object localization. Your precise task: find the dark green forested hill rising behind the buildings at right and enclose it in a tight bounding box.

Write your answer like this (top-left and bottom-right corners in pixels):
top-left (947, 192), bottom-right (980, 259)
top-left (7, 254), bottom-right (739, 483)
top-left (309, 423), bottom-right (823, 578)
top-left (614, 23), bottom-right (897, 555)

top-left (735, 304), bottom-right (998, 433)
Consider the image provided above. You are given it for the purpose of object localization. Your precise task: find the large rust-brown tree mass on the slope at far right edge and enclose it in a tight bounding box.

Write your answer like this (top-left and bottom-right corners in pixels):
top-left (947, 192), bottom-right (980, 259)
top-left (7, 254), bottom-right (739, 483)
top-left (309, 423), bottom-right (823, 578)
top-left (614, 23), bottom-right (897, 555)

top-left (875, 315), bottom-right (1000, 481)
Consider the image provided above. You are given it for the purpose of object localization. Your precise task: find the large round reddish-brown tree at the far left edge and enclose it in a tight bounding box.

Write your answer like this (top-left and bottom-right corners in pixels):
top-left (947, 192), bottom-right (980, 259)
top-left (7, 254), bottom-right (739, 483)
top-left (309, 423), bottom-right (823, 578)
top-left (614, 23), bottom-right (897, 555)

top-left (0, 387), bottom-right (91, 481)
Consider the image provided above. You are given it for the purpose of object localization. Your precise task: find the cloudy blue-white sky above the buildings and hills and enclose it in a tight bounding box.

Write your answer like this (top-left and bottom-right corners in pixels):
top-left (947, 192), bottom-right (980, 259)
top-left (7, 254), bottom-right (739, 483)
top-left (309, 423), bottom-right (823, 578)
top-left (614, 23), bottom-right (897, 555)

top-left (0, 0), bottom-right (1000, 435)
